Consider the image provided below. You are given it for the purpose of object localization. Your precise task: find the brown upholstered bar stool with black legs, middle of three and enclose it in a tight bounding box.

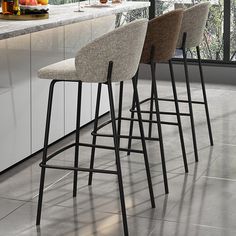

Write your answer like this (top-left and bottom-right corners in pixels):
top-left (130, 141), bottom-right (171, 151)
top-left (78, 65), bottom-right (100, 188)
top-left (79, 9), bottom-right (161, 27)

top-left (128, 10), bottom-right (188, 193)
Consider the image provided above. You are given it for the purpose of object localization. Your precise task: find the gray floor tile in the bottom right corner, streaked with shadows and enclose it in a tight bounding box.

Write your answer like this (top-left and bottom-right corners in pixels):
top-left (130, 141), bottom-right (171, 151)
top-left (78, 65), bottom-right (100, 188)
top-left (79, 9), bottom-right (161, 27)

top-left (166, 177), bottom-right (236, 230)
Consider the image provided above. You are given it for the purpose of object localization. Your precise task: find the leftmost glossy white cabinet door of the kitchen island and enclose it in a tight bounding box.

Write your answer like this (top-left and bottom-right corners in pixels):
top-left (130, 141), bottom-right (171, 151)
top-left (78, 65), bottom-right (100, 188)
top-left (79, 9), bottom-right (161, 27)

top-left (0, 35), bottom-right (31, 171)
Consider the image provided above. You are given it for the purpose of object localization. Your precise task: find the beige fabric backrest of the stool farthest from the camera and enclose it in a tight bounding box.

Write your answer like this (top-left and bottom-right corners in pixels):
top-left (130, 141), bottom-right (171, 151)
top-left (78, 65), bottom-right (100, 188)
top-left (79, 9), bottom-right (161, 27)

top-left (177, 2), bottom-right (210, 48)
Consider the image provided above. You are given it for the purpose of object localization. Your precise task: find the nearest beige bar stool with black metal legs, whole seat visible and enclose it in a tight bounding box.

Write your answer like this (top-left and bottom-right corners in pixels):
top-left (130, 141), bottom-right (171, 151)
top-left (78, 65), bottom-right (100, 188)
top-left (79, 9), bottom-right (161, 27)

top-left (36, 19), bottom-right (155, 236)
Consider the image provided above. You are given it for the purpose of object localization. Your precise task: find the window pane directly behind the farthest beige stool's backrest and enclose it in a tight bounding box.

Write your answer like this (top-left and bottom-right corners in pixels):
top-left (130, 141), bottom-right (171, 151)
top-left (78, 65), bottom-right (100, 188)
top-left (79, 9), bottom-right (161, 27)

top-left (156, 0), bottom-right (224, 60)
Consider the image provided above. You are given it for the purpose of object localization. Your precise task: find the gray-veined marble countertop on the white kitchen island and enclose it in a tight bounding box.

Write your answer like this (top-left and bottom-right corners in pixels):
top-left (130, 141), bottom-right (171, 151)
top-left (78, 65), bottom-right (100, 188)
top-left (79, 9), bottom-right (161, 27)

top-left (0, 1), bottom-right (150, 40)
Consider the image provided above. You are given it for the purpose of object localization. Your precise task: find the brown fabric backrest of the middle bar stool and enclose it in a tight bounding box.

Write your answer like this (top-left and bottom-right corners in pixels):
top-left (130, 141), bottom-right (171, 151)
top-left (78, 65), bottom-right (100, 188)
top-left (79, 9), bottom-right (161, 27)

top-left (141, 9), bottom-right (183, 64)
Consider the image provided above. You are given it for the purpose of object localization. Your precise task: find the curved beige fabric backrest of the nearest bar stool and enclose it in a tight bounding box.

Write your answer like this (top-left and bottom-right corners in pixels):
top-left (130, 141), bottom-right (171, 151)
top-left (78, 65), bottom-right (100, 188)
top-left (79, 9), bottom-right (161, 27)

top-left (75, 19), bottom-right (148, 82)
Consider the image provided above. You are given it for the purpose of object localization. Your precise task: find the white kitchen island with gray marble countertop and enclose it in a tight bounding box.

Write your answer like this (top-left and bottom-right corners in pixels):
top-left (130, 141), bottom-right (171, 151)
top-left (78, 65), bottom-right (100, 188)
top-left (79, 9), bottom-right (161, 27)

top-left (0, 2), bottom-right (149, 172)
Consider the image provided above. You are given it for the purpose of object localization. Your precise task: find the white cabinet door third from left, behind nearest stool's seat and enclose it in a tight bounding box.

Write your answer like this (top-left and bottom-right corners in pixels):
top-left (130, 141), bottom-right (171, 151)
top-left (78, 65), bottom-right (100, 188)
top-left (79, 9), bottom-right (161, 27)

top-left (65, 21), bottom-right (92, 134)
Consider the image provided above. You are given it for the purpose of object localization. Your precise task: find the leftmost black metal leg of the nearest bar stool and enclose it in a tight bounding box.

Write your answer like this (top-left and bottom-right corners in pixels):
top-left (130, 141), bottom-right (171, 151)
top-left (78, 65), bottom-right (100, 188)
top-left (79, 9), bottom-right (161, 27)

top-left (36, 80), bottom-right (57, 225)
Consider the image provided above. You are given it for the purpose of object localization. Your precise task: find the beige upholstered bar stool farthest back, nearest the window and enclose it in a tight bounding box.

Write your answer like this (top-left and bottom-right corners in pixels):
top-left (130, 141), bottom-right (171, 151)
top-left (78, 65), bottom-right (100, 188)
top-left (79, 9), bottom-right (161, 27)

top-left (177, 2), bottom-right (213, 161)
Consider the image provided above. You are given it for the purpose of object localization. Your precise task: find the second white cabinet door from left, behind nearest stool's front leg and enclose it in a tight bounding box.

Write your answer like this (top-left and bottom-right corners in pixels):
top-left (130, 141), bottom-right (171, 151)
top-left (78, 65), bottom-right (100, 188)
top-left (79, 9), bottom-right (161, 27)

top-left (31, 27), bottom-right (64, 152)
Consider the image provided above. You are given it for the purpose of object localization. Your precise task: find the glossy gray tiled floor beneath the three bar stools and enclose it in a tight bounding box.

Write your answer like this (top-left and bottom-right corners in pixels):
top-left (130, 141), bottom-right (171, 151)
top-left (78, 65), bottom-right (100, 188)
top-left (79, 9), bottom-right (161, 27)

top-left (0, 81), bottom-right (236, 236)
